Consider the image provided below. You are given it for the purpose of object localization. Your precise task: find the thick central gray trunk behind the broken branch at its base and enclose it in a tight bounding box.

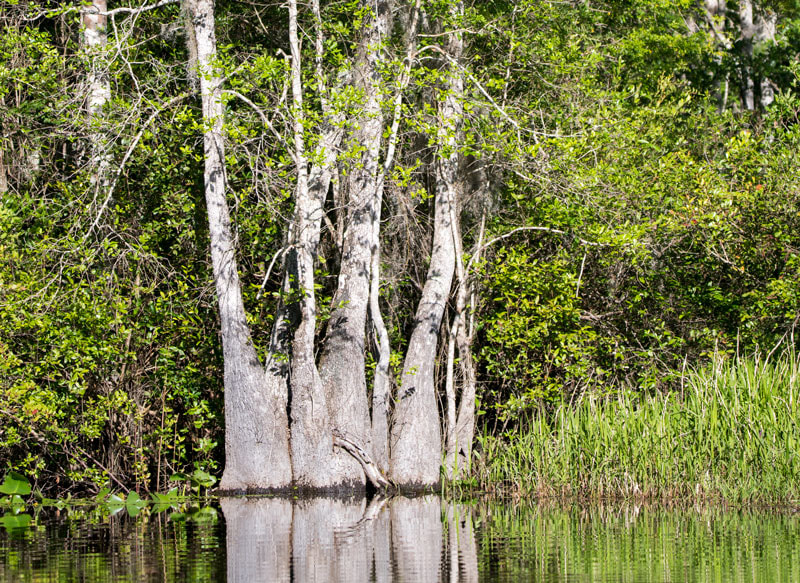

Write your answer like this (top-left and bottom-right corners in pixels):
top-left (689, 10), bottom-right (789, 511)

top-left (320, 0), bottom-right (391, 484)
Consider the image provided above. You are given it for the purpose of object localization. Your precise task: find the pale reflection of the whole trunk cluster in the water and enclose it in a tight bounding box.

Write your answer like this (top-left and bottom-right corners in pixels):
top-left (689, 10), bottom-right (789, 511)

top-left (221, 496), bottom-right (478, 583)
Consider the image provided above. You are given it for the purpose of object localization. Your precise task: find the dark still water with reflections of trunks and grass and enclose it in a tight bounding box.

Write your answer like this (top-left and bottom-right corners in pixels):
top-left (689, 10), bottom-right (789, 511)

top-left (0, 496), bottom-right (800, 583)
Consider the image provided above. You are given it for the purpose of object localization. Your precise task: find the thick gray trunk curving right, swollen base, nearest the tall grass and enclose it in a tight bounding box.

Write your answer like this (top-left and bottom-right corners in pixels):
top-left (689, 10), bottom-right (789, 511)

top-left (391, 3), bottom-right (464, 488)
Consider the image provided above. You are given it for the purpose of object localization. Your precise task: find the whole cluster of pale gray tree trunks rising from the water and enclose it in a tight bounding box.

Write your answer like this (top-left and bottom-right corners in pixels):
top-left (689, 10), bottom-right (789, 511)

top-left (186, 0), bottom-right (474, 492)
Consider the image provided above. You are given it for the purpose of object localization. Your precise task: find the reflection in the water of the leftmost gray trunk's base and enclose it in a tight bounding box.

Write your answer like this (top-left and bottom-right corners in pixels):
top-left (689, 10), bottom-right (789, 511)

top-left (220, 498), bottom-right (292, 583)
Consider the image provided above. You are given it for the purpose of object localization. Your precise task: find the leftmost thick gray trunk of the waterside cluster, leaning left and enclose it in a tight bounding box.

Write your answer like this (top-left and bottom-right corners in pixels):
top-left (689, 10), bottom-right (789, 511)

top-left (187, 0), bottom-right (292, 491)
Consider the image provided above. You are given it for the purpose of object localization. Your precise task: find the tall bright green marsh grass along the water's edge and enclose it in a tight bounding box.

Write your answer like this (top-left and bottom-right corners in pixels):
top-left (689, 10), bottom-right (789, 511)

top-left (475, 351), bottom-right (800, 503)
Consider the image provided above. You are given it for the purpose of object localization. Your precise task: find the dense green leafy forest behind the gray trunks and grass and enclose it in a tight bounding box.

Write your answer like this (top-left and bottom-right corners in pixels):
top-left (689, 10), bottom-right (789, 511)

top-left (0, 0), bottom-right (800, 494)
